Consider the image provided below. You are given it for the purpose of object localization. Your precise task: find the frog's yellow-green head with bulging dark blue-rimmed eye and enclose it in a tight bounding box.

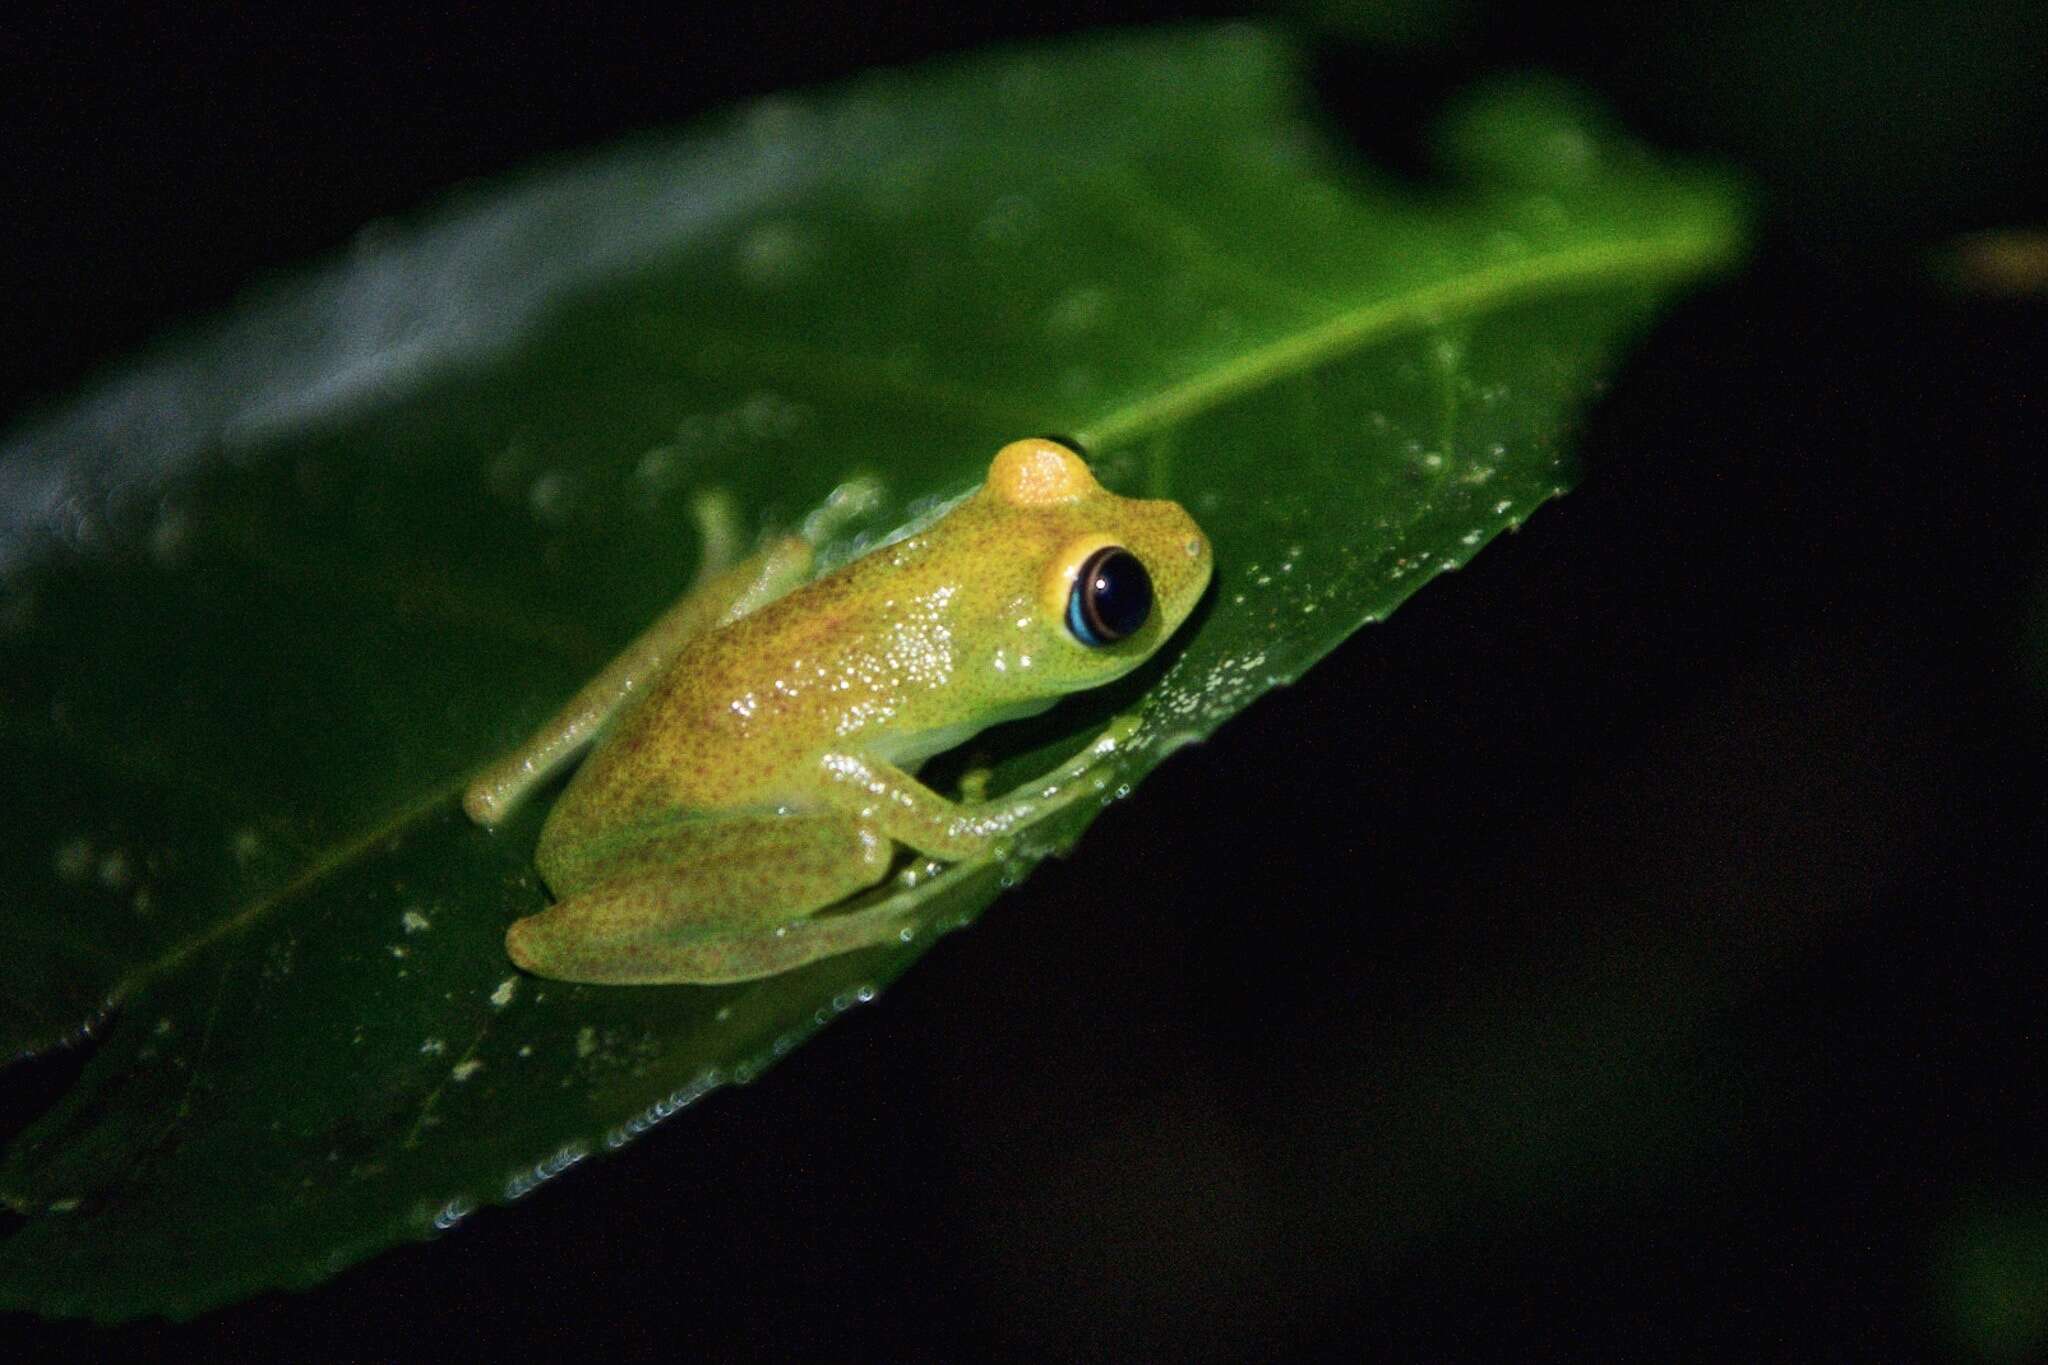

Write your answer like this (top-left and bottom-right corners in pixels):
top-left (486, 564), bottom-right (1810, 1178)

top-left (975, 438), bottom-right (1210, 700)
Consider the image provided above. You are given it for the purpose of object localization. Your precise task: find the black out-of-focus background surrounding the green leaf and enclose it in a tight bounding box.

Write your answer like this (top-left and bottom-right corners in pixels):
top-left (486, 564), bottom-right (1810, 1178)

top-left (0, 0), bottom-right (2048, 1359)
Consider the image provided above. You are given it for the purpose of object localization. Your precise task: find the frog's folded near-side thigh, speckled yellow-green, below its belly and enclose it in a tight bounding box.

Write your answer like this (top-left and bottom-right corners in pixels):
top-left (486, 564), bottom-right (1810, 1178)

top-left (506, 814), bottom-right (893, 984)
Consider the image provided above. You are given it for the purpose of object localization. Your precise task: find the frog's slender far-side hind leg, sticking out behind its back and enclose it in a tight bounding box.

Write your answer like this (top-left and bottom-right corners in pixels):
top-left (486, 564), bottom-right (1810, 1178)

top-left (463, 501), bottom-right (813, 825)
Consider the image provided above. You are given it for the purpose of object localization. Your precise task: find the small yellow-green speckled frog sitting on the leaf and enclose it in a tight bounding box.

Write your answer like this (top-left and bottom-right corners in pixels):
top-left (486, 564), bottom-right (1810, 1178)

top-left (463, 438), bottom-right (1212, 986)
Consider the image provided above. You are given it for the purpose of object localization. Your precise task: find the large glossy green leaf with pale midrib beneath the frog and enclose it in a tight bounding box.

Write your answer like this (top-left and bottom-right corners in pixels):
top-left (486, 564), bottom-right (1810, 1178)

top-left (0, 29), bottom-right (1739, 1318)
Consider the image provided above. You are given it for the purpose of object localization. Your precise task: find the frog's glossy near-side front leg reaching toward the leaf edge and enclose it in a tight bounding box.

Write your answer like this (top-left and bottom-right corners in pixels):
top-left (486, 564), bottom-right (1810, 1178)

top-left (823, 716), bottom-right (1139, 862)
